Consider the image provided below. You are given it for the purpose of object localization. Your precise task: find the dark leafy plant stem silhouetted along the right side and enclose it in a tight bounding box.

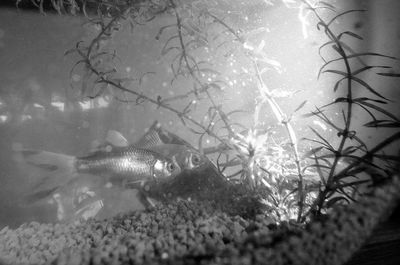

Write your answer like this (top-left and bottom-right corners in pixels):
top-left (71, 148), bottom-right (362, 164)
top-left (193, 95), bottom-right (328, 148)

top-left (302, 0), bottom-right (400, 221)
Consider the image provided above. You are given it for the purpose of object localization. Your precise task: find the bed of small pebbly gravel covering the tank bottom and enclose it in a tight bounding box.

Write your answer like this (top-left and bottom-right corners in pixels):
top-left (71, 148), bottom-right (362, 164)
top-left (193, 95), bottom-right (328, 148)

top-left (0, 177), bottom-right (400, 265)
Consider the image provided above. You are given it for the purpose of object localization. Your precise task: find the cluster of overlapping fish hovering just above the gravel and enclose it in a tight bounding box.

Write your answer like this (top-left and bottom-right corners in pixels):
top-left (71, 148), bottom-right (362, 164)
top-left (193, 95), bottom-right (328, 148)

top-left (18, 121), bottom-right (222, 222)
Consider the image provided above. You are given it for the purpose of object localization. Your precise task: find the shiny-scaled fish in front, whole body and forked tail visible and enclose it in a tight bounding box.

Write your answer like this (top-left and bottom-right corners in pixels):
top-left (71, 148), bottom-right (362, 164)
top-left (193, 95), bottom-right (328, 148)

top-left (19, 142), bottom-right (181, 201)
